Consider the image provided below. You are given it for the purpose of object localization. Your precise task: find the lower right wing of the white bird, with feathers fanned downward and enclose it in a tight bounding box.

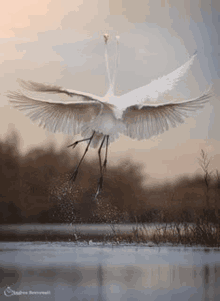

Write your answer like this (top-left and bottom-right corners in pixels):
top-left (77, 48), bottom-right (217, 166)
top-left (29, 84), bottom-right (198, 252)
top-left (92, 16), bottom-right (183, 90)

top-left (122, 91), bottom-right (212, 140)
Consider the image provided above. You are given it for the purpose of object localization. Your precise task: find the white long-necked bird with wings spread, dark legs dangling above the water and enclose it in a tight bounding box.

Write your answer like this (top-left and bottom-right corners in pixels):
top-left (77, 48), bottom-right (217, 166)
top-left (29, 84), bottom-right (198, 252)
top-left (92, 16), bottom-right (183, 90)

top-left (8, 34), bottom-right (211, 196)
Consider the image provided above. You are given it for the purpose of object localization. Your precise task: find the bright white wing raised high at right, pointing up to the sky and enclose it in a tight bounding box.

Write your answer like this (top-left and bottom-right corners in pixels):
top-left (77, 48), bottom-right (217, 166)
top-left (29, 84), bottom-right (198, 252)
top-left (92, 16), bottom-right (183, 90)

top-left (121, 53), bottom-right (196, 106)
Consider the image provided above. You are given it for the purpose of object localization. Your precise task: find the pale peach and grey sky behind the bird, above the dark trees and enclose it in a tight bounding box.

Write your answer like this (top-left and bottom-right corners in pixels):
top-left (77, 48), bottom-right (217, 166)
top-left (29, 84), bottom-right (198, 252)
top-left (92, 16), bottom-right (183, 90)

top-left (0, 0), bottom-right (220, 183)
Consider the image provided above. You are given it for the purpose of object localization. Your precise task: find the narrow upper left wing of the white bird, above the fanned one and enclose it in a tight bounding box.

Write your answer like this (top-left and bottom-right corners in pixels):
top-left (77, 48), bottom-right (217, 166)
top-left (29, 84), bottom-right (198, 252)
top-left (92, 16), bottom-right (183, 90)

top-left (19, 79), bottom-right (99, 101)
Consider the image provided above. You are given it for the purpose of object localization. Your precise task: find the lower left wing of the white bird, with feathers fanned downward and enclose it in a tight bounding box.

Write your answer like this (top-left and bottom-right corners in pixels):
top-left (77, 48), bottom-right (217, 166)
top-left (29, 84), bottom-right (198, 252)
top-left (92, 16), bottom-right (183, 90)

top-left (7, 92), bottom-right (102, 135)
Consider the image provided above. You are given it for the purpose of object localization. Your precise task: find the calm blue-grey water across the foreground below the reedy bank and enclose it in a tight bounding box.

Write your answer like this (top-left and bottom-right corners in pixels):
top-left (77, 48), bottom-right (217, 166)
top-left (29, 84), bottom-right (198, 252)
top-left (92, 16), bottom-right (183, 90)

top-left (0, 242), bottom-right (220, 301)
